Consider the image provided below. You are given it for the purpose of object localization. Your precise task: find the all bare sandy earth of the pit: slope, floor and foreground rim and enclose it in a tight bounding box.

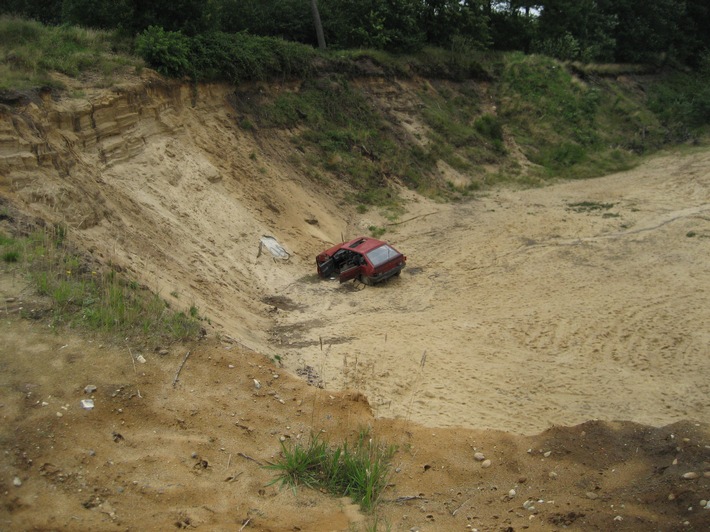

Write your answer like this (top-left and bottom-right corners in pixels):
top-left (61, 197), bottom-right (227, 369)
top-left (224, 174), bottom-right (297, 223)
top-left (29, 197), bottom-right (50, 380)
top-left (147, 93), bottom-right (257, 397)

top-left (0, 77), bottom-right (710, 531)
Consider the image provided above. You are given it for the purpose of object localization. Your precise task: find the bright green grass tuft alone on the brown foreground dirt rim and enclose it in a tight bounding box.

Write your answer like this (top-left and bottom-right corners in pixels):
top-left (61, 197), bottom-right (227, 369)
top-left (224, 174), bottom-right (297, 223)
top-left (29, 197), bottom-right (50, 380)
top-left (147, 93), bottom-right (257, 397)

top-left (267, 430), bottom-right (395, 511)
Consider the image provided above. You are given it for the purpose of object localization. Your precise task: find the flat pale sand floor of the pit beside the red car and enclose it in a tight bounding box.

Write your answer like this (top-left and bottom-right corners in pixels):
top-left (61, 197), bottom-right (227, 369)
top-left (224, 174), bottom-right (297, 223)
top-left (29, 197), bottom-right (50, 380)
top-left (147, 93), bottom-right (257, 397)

top-left (273, 148), bottom-right (710, 434)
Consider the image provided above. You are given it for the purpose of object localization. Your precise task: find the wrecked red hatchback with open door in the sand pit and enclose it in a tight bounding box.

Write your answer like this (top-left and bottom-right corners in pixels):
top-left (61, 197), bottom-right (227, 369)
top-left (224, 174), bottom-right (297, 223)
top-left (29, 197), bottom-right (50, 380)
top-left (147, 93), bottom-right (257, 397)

top-left (316, 236), bottom-right (407, 285)
